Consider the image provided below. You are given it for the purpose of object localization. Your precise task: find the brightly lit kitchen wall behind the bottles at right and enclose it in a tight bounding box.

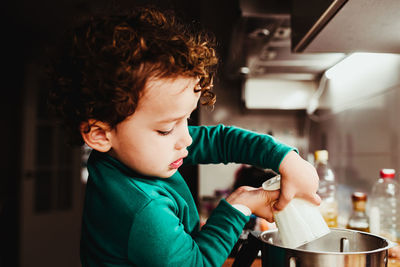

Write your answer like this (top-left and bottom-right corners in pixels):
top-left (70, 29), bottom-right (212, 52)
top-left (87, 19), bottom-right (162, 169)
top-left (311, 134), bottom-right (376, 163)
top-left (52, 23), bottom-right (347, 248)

top-left (310, 55), bottom-right (400, 223)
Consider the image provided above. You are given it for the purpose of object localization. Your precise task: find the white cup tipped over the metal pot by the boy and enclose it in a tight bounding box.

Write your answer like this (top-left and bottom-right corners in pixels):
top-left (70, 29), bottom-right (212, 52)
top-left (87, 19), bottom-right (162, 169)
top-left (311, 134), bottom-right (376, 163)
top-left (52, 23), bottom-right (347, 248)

top-left (262, 175), bottom-right (330, 248)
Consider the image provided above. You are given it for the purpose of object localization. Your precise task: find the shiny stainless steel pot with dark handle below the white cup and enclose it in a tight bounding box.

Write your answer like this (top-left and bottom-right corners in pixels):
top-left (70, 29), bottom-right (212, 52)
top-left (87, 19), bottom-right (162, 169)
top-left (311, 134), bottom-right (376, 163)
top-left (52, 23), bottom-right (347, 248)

top-left (232, 228), bottom-right (394, 267)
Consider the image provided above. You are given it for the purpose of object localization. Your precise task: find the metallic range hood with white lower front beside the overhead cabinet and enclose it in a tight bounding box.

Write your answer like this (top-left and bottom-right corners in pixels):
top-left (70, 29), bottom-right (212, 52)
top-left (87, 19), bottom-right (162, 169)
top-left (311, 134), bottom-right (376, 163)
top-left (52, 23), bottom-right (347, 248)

top-left (226, 0), bottom-right (345, 110)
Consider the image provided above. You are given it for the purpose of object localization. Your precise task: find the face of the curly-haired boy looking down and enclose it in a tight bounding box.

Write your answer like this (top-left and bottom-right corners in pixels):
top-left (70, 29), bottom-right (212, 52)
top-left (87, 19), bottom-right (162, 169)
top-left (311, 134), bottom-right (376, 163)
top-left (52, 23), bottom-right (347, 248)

top-left (110, 77), bottom-right (200, 178)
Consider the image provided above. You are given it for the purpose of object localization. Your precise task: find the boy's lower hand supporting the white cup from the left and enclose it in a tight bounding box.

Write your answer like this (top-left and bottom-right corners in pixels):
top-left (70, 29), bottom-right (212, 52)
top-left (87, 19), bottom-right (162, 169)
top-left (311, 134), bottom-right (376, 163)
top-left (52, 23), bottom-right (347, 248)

top-left (226, 186), bottom-right (279, 223)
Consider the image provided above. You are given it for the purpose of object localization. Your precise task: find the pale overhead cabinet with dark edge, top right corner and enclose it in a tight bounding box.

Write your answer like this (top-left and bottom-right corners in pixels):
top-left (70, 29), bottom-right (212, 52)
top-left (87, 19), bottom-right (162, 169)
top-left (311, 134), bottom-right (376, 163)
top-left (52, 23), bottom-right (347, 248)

top-left (291, 0), bottom-right (400, 53)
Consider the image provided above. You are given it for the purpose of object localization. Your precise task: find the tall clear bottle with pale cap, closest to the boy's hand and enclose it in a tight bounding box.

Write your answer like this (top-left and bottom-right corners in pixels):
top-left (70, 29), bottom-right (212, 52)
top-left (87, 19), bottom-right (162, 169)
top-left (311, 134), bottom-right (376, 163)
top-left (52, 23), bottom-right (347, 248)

top-left (314, 150), bottom-right (338, 227)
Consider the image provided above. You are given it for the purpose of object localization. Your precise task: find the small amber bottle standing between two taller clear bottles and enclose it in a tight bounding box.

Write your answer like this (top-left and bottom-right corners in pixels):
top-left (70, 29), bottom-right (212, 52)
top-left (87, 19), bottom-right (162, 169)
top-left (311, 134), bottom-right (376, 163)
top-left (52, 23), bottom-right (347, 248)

top-left (347, 192), bottom-right (369, 232)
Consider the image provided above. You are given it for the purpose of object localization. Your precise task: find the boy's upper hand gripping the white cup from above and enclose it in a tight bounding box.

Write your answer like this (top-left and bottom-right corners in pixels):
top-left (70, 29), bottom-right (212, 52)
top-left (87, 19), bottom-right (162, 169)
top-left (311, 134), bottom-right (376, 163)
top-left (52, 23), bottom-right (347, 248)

top-left (274, 151), bottom-right (321, 210)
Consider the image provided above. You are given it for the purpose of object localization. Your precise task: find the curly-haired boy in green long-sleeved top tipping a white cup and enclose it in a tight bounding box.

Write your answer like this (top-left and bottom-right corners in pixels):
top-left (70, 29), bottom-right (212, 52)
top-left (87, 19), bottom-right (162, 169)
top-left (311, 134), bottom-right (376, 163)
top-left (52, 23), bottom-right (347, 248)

top-left (50, 8), bottom-right (320, 266)
